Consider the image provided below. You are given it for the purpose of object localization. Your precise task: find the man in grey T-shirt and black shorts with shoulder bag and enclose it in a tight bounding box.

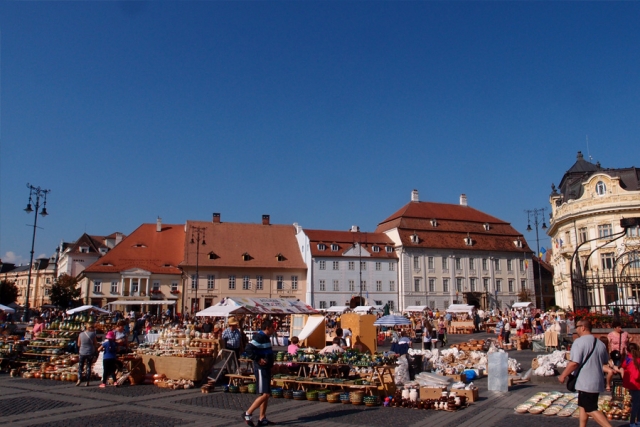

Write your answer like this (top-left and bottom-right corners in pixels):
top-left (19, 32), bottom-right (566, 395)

top-left (558, 319), bottom-right (611, 427)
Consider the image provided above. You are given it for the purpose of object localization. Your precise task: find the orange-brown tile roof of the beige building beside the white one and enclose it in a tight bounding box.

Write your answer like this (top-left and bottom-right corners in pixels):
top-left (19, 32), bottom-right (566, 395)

top-left (181, 221), bottom-right (307, 269)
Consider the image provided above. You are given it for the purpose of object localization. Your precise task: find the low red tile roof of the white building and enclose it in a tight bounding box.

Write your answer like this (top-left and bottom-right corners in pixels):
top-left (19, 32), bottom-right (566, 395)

top-left (304, 229), bottom-right (398, 259)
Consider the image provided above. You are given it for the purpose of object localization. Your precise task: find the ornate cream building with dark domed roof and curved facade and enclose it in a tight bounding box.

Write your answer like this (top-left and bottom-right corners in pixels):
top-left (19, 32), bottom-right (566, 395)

top-left (547, 151), bottom-right (640, 310)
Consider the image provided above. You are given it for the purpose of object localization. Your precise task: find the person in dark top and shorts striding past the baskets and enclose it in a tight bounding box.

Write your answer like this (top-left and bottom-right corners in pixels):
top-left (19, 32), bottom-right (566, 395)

top-left (242, 319), bottom-right (275, 427)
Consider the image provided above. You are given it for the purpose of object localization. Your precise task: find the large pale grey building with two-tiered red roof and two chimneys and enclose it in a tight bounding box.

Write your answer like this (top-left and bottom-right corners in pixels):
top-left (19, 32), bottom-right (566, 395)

top-left (376, 190), bottom-right (534, 310)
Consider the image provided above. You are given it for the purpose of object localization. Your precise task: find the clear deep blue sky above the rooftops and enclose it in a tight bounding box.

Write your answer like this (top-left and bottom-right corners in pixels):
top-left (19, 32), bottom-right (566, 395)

top-left (0, 1), bottom-right (640, 263)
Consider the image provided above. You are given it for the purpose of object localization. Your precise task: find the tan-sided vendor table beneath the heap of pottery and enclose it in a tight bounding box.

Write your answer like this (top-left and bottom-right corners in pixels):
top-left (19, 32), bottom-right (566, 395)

top-left (142, 354), bottom-right (213, 381)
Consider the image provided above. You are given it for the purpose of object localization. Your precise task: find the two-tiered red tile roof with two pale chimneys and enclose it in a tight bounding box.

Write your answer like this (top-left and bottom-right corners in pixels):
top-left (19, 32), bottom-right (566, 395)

top-left (376, 202), bottom-right (531, 253)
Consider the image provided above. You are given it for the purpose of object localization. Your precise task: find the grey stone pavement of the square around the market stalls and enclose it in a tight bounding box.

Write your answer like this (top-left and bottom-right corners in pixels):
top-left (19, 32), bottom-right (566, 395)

top-left (0, 334), bottom-right (628, 427)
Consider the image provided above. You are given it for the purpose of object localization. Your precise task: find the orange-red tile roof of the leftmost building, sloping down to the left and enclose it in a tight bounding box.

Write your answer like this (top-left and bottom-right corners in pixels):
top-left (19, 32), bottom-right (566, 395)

top-left (84, 223), bottom-right (185, 274)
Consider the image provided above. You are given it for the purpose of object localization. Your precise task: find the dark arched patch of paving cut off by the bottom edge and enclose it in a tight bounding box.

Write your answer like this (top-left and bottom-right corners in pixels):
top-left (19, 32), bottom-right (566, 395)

top-left (23, 411), bottom-right (193, 427)
